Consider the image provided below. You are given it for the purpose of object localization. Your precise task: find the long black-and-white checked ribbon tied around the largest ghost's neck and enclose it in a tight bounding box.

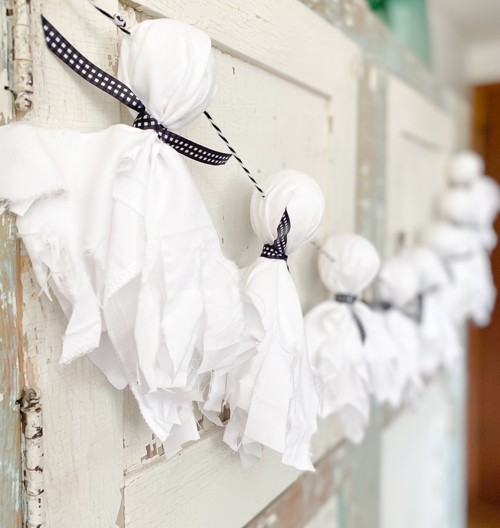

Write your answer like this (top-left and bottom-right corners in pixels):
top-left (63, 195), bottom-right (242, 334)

top-left (42, 16), bottom-right (232, 165)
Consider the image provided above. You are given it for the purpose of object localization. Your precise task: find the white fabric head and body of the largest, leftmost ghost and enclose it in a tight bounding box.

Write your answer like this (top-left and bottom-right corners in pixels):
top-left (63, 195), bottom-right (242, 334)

top-left (0, 20), bottom-right (251, 454)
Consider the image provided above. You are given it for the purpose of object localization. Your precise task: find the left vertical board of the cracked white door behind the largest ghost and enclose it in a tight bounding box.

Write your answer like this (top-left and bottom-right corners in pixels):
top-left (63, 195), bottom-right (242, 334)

top-left (21, 0), bottom-right (123, 528)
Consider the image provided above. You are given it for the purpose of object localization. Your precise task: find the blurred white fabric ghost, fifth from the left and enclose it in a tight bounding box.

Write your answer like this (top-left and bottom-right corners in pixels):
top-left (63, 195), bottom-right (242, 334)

top-left (403, 246), bottom-right (463, 377)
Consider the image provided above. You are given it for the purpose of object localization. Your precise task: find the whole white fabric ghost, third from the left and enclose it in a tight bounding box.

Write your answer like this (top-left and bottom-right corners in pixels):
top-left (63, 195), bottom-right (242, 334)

top-left (305, 234), bottom-right (396, 443)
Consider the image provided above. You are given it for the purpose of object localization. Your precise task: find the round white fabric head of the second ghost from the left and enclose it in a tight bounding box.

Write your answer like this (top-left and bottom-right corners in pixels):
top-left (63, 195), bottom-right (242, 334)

top-left (250, 170), bottom-right (325, 254)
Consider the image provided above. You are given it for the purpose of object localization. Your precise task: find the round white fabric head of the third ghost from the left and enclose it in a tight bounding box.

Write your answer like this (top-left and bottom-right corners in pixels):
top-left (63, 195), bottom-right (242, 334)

top-left (318, 234), bottom-right (380, 295)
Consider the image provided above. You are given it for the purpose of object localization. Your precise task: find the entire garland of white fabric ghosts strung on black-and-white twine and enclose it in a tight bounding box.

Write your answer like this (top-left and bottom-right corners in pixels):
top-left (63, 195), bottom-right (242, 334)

top-left (0, 2), bottom-right (500, 470)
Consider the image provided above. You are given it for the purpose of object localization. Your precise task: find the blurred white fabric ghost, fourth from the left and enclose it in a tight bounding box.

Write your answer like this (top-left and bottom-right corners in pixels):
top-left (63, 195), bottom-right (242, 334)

top-left (377, 255), bottom-right (422, 404)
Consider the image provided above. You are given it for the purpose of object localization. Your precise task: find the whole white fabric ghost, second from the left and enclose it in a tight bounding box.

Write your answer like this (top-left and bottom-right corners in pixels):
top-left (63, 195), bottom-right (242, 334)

top-left (220, 170), bottom-right (324, 470)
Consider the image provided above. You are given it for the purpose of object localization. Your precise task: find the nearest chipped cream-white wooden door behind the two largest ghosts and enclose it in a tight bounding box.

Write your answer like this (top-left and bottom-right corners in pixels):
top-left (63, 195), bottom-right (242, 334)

top-left (18, 0), bottom-right (360, 528)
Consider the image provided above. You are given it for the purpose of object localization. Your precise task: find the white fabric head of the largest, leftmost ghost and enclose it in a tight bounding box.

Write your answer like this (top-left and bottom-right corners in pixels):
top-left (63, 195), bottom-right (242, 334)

top-left (118, 19), bottom-right (216, 130)
